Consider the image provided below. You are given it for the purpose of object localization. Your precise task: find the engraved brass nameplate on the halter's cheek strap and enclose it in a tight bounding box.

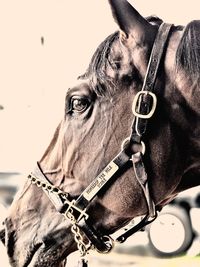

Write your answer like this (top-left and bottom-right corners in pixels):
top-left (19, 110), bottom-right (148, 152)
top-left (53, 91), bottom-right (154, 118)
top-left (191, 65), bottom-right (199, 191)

top-left (83, 161), bottom-right (119, 201)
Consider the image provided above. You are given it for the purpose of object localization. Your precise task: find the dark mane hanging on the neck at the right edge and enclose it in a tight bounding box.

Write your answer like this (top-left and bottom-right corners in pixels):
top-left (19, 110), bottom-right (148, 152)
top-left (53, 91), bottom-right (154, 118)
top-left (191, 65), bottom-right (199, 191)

top-left (176, 20), bottom-right (200, 82)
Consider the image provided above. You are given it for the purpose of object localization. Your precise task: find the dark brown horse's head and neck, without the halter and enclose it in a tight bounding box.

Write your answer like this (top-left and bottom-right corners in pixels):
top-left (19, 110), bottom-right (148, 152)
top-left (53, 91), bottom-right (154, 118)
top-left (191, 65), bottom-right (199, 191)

top-left (1, 0), bottom-right (200, 267)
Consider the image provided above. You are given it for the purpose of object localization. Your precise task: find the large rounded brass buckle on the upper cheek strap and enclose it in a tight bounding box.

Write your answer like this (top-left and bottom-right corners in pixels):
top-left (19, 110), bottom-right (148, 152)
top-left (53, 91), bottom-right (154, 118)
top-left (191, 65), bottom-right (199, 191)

top-left (132, 91), bottom-right (157, 119)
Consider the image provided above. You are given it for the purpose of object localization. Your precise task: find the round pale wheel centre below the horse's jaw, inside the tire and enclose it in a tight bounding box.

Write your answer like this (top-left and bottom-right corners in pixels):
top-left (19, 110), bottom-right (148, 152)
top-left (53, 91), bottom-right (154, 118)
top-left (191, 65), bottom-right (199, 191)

top-left (149, 214), bottom-right (185, 253)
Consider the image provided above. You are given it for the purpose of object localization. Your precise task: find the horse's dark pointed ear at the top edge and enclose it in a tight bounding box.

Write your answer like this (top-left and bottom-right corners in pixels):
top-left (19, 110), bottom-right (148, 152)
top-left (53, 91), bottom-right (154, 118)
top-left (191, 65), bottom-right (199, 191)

top-left (109, 0), bottom-right (156, 43)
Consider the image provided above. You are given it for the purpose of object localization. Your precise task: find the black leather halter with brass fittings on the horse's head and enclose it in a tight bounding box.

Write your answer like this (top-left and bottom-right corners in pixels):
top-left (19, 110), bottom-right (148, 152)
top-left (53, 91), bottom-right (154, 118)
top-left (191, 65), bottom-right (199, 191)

top-left (28, 23), bottom-right (172, 258)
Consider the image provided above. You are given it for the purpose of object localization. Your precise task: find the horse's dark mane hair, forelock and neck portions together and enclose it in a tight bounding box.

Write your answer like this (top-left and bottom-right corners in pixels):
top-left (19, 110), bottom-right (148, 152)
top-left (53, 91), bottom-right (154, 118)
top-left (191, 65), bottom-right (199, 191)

top-left (79, 16), bottom-right (200, 95)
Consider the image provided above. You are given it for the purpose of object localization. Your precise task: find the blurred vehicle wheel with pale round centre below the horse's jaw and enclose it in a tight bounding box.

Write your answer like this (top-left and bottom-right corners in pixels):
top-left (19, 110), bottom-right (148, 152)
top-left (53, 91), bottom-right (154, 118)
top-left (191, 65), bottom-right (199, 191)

top-left (148, 205), bottom-right (193, 257)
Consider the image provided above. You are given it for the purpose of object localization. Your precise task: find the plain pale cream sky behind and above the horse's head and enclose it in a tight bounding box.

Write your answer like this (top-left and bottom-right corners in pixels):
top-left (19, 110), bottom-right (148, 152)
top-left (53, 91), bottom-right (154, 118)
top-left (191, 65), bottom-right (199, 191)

top-left (0, 0), bottom-right (200, 171)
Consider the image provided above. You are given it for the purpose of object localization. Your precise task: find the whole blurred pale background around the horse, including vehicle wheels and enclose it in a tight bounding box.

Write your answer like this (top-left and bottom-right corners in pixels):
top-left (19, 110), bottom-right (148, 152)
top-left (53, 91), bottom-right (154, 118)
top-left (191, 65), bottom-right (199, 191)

top-left (0, 0), bottom-right (200, 267)
